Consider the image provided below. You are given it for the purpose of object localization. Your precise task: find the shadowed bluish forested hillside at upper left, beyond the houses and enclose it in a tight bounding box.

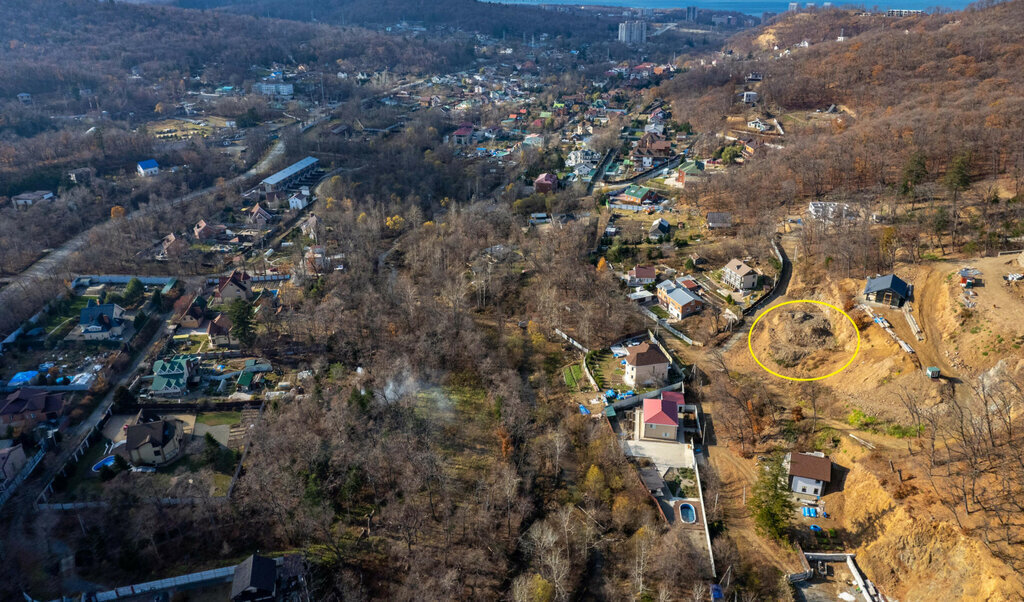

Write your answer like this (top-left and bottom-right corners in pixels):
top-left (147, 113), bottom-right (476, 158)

top-left (0, 0), bottom-right (468, 100)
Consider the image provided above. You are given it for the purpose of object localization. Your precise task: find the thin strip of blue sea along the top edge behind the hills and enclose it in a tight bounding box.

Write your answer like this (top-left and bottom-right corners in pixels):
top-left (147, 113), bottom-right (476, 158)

top-left (486, 0), bottom-right (971, 16)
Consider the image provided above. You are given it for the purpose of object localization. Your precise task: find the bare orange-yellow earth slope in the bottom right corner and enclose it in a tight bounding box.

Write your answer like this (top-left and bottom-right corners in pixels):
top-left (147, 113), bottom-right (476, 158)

top-left (829, 464), bottom-right (1024, 601)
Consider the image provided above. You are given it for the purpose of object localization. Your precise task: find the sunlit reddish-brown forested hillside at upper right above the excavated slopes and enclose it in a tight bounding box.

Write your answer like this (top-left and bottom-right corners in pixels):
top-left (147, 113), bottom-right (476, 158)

top-left (660, 0), bottom-right (1024, 269)
